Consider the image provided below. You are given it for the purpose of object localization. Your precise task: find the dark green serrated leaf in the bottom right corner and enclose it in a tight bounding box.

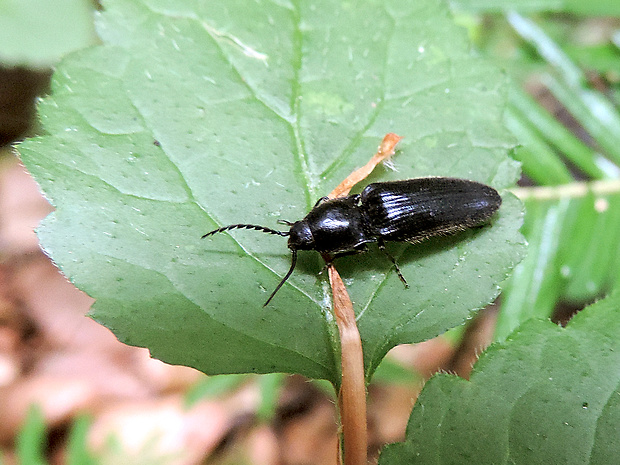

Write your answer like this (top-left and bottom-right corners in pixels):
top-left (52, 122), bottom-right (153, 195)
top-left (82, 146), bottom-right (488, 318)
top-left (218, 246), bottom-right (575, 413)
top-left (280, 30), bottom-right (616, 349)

top-left (379, 293), bottom-right (620, 465)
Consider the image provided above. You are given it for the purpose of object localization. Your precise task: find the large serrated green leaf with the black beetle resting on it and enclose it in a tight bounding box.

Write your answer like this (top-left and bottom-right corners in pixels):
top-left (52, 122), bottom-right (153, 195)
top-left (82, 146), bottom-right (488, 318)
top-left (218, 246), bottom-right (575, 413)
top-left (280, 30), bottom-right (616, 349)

top-left (20, 0), bottom-right (523, 384)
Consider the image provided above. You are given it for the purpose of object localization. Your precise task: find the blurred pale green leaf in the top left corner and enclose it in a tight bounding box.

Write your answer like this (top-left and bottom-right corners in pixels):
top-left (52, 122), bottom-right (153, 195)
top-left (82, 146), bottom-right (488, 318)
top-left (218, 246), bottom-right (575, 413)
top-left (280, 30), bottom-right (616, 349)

top-left (0, 0), bottom-right (95, 67)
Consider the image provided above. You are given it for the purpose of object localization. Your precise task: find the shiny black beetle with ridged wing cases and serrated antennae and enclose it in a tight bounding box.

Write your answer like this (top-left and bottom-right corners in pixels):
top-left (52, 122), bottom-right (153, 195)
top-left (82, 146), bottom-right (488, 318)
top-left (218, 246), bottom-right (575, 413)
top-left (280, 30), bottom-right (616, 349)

top-left (202, 177), bottom-right (502, 306)
